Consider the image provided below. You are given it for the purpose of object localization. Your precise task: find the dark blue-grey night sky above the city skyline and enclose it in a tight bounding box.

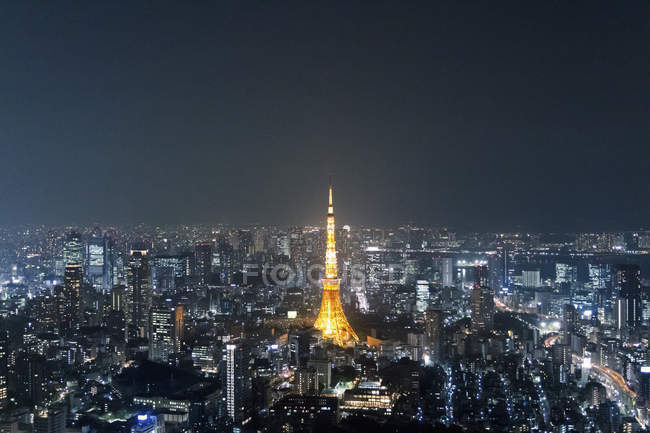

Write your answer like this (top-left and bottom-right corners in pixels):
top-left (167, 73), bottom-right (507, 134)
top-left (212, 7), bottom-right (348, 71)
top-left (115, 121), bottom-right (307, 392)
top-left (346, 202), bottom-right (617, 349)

top-left (0, 0), bottom-right (650, 230)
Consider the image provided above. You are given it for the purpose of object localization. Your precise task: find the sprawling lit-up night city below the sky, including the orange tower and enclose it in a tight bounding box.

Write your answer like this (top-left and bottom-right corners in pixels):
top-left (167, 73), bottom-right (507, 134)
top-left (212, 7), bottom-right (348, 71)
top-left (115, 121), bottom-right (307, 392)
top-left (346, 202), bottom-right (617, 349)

top-left (0, 187), bottom-right (650, 432)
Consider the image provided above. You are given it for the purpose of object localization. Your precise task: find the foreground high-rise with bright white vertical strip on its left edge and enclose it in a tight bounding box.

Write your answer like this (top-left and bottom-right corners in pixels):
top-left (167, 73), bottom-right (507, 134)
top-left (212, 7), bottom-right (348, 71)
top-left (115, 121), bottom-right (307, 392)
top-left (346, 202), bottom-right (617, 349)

top-left (225, 344), bottom-right (252, 424)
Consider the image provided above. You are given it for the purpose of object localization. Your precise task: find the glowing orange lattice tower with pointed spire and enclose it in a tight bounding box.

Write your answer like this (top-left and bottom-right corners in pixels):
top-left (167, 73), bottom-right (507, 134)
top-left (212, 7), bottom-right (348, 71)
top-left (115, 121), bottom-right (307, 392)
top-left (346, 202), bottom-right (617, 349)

top-left (314, 186), bottom-right (359, 346)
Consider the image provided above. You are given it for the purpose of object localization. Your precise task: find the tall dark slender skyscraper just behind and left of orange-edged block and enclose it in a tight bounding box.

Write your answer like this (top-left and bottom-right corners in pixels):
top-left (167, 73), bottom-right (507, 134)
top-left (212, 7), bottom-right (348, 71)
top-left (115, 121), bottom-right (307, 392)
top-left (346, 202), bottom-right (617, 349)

top-left (126, 246), bottom-right (153, 337)
